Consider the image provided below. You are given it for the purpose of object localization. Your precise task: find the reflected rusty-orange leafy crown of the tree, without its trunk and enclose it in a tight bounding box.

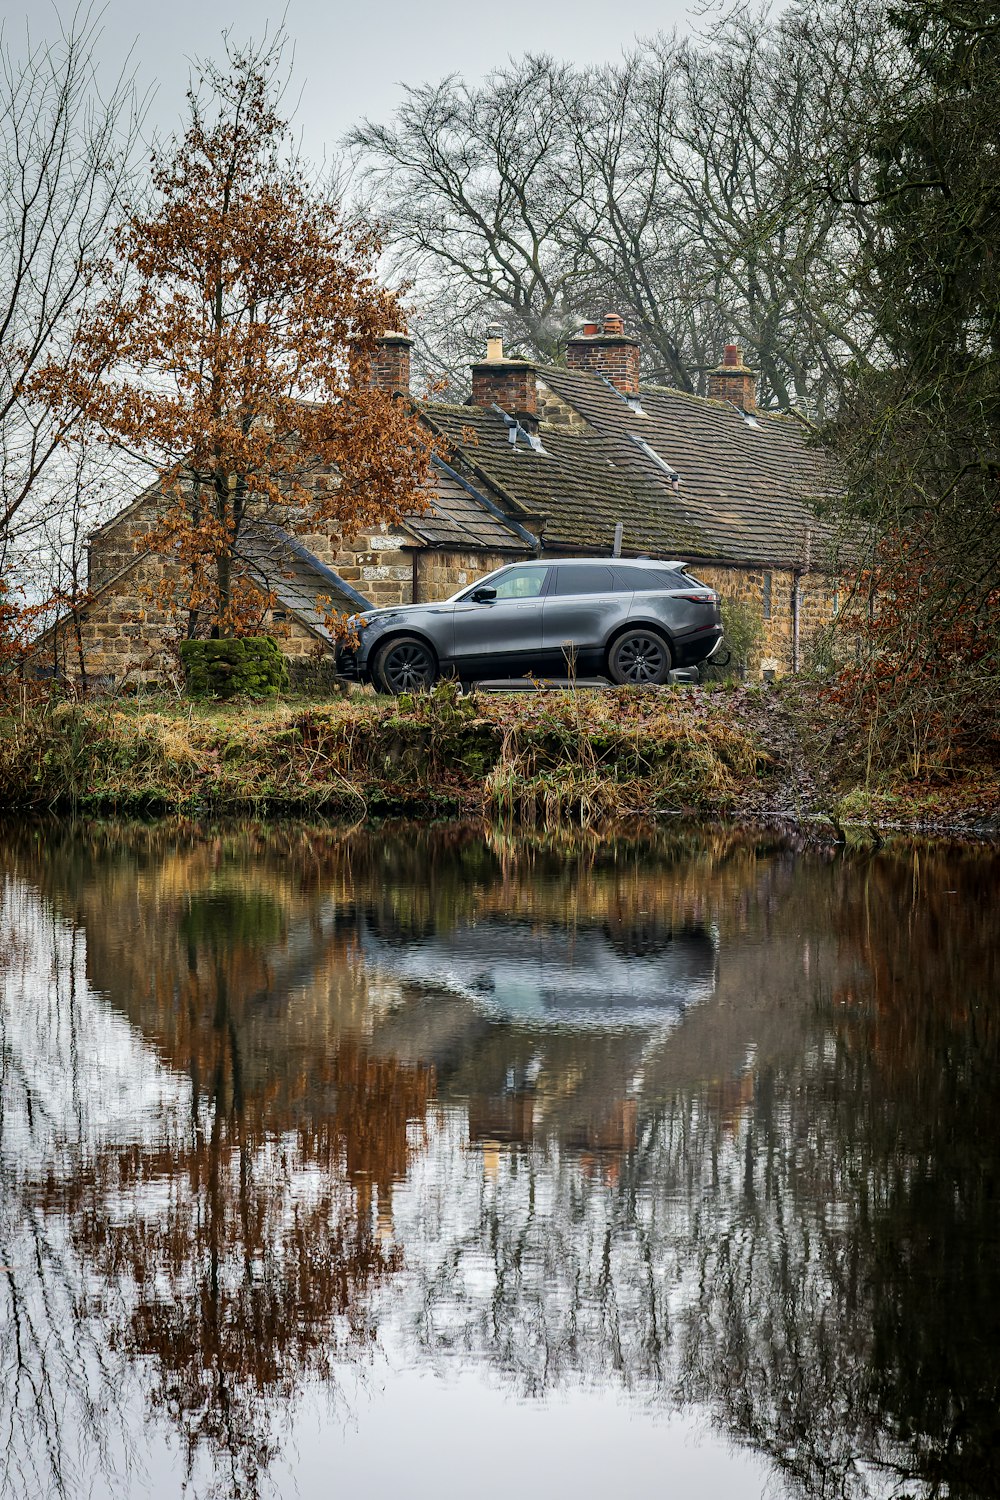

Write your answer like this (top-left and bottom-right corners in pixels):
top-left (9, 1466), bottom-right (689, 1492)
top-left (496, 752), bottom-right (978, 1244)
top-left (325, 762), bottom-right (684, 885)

top-left (64, 1037), bottom-right (427, 1494)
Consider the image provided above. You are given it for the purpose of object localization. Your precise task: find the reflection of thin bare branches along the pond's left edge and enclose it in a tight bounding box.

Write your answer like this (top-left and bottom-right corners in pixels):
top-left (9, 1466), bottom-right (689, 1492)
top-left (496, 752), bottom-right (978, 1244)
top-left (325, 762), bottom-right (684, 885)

top-left (0, 882), bottom-right (129, 1500)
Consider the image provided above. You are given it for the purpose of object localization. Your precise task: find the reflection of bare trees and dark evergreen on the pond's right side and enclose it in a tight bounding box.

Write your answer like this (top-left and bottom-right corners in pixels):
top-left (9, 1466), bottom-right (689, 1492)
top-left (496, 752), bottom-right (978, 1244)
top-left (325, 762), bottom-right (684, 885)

top-left (400, 851), bottom-right (1000, 1500)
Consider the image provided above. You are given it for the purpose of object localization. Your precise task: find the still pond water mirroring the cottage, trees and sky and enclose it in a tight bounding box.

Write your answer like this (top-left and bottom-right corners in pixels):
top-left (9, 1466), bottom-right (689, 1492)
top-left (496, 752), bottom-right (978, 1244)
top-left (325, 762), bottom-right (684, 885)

top-left (0, 825), bottom-right (1000, 1500)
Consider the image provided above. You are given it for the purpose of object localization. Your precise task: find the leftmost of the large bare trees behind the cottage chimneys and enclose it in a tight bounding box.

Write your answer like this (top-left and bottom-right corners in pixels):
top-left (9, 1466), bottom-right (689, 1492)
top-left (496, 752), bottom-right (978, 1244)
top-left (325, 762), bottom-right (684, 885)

top-left (348, 56), bottom-right (588, 387)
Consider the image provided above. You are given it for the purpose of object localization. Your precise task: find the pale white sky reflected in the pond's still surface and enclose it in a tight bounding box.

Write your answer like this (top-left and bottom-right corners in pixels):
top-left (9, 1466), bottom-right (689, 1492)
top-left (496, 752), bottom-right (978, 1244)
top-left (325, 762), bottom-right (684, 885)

top-left (0, 891), bottom-right (777, 1500)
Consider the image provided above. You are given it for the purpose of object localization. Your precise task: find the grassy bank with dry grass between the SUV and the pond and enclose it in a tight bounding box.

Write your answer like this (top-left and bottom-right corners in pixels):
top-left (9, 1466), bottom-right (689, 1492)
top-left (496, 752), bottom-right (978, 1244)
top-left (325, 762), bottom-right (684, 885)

top-left (0, 684), bottom-right (996, 827)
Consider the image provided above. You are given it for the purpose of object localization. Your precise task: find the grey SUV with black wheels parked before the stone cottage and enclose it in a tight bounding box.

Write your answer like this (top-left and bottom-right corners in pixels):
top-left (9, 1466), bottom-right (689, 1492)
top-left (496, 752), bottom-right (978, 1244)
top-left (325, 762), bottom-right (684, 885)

top-left (339, 558), bottom-right (723, 693)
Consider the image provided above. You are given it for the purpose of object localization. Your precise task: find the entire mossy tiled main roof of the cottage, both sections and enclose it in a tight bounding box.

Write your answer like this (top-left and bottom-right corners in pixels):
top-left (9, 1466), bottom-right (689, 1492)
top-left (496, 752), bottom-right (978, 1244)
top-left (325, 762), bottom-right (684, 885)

top-left (421, 366), bottom-right (834, 567)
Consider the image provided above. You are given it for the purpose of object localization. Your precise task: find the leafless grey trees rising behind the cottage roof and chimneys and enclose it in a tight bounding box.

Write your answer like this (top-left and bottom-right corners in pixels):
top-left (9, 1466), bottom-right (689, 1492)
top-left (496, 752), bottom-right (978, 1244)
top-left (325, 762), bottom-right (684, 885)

top-left (348, 0), bottom-right (895, 410)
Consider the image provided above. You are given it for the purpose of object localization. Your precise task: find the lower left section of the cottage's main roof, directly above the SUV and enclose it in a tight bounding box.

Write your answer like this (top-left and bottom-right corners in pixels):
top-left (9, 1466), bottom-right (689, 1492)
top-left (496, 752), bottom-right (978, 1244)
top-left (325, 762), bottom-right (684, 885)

top-left (419, 402), bottom-right (705, 557)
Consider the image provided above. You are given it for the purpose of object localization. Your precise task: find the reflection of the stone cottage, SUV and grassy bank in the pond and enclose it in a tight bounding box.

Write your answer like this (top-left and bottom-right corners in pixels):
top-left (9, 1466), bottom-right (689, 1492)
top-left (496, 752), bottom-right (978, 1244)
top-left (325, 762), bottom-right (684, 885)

top-left (3, 831), bottom-right (833, 1172)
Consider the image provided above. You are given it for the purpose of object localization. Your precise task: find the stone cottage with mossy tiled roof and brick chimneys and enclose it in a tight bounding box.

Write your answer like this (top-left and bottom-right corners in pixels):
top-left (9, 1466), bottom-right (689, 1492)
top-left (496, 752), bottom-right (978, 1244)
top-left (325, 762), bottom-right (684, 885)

top-left (39, 314), bottom-right (837, 681)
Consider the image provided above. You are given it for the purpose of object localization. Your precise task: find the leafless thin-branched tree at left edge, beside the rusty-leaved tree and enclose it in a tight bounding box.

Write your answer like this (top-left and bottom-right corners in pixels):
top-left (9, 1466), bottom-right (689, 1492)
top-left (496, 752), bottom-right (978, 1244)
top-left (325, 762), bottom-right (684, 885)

top-left (0, 9), bottom-right (144, 576)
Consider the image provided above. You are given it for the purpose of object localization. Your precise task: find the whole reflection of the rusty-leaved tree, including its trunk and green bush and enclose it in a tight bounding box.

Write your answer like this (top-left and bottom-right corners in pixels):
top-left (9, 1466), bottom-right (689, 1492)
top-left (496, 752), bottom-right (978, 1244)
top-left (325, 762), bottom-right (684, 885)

top-left (0, 858), bottom-right (433, 1496)
